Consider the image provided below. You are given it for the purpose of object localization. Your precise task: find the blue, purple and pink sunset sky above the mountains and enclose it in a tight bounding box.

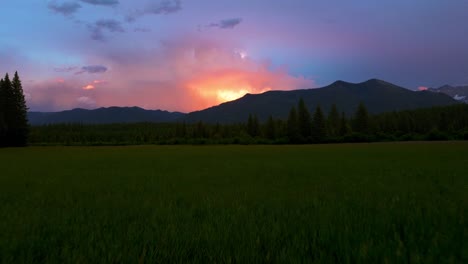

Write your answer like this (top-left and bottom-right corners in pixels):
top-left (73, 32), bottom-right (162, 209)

top-left (0, 0), bottom-right (468, 112)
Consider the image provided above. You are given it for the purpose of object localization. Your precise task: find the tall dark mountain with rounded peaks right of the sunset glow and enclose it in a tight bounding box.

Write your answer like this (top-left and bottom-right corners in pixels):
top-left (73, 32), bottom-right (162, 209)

top-left (183, 79), bottom-right (457, 123)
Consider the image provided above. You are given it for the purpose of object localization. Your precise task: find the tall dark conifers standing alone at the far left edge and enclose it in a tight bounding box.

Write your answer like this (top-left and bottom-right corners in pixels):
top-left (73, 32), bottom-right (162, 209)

top-left (0, 72), bottom-right (29, 147)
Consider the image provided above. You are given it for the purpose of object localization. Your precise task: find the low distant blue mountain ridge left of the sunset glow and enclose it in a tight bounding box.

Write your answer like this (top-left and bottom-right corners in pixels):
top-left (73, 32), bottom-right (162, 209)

top-left (28, 107), bottom-right (185, 125)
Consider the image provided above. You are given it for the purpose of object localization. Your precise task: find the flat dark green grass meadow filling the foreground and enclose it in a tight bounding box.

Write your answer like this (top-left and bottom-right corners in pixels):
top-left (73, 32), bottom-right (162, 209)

top-left (0, 142), bottom-right (468, 263)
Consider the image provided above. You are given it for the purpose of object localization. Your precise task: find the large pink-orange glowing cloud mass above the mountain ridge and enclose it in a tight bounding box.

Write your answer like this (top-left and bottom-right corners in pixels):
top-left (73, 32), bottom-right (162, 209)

top-left (27, 37), bottom-right (316, 112)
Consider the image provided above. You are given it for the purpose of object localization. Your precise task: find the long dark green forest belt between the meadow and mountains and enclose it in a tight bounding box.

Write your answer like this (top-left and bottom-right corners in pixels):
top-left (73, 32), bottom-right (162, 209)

top-left (29, 99), bottom-right (468, 145)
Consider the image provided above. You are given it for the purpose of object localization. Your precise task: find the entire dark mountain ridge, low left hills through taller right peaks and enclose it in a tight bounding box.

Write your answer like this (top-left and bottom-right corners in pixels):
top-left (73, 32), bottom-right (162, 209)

top-left (28, 79), bottom-right (459, 125)
